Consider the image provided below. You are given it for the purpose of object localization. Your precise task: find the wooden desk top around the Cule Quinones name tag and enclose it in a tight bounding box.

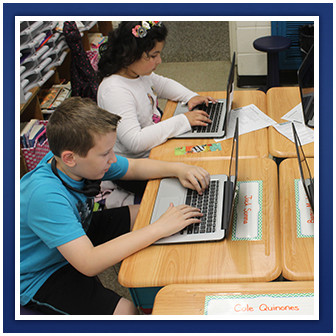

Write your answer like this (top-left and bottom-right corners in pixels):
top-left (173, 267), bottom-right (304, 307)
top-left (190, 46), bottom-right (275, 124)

top-left (152, 281), bottom-right (314, 315)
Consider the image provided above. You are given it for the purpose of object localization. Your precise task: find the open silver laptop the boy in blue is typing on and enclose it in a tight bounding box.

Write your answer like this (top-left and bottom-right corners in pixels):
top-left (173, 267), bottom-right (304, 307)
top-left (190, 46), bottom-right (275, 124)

top-left (150, 118), bottom-right (239, 244)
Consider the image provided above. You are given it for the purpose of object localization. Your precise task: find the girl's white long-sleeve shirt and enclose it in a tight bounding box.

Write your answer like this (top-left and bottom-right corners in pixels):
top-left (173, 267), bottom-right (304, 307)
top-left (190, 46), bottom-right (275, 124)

top-left (97, 73), bottom-right (197, 158)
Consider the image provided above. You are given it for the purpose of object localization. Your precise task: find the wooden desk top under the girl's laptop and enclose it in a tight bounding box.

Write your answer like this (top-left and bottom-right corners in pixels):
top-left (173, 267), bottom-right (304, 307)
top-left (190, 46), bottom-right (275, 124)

top-left (149, 90), bottom-right (268, 161)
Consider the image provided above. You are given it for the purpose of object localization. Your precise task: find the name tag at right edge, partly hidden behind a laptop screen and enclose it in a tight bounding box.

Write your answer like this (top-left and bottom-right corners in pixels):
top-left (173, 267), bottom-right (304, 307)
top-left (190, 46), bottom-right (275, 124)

top-left (294, 179), bottom-right (314, 238)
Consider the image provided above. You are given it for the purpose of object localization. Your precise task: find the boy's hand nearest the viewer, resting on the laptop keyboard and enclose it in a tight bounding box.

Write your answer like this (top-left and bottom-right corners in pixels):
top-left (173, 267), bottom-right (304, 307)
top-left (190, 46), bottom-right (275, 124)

top-left (152, 203), bottom-right (203, 238)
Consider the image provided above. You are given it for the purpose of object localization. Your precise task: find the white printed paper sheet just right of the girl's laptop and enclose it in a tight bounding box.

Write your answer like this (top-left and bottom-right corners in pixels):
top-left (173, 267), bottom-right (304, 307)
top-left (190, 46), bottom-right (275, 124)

top-left (214, 104), bottom-right (276, 142)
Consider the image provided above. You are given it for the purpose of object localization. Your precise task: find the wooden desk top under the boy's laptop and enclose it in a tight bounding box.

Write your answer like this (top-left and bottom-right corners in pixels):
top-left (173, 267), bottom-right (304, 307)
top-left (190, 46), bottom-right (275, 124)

top-left (119, 159), bottom-right (281, 308)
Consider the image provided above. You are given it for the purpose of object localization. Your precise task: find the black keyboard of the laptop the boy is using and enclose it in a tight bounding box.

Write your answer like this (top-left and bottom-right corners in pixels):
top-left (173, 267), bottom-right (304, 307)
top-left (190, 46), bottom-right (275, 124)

top-left (180, 180), bottom-right (219, 234)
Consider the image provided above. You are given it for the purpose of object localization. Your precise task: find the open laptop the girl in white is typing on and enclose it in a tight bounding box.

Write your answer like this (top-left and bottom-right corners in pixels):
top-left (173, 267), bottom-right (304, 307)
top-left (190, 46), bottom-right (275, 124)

top-left (174, 53), bottom-right (236, 139)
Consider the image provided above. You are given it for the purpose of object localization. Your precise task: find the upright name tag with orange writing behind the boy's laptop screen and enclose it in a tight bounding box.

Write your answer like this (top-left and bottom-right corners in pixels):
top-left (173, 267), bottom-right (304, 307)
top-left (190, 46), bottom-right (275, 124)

top-left (231, 181), bottom-right (263, 240)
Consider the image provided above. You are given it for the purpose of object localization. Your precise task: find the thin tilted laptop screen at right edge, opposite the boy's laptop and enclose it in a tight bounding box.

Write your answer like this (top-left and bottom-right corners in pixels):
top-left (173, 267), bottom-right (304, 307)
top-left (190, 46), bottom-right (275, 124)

top-left (292, 123), bottom-right (314, 212)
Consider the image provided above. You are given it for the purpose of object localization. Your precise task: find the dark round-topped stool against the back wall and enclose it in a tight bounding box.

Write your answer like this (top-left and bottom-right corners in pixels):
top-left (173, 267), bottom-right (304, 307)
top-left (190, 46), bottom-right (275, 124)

top-left (253, 36), bottom-right (291, 92)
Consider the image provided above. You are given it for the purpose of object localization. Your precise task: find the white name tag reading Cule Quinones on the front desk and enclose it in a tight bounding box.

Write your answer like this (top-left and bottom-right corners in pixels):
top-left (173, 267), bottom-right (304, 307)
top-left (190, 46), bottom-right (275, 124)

top-left (204, 293), bottom-right (314, 317)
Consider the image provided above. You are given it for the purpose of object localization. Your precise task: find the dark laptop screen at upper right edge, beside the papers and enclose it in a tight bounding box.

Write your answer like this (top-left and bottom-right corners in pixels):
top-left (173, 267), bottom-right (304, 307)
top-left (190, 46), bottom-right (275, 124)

top-left (298, 45), bottom-right (314, 127)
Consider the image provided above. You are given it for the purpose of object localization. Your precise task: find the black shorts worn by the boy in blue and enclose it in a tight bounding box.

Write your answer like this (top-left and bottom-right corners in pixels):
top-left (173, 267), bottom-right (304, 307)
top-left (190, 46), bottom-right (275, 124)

top-left (26, 206), bottom-right (130, 315)
